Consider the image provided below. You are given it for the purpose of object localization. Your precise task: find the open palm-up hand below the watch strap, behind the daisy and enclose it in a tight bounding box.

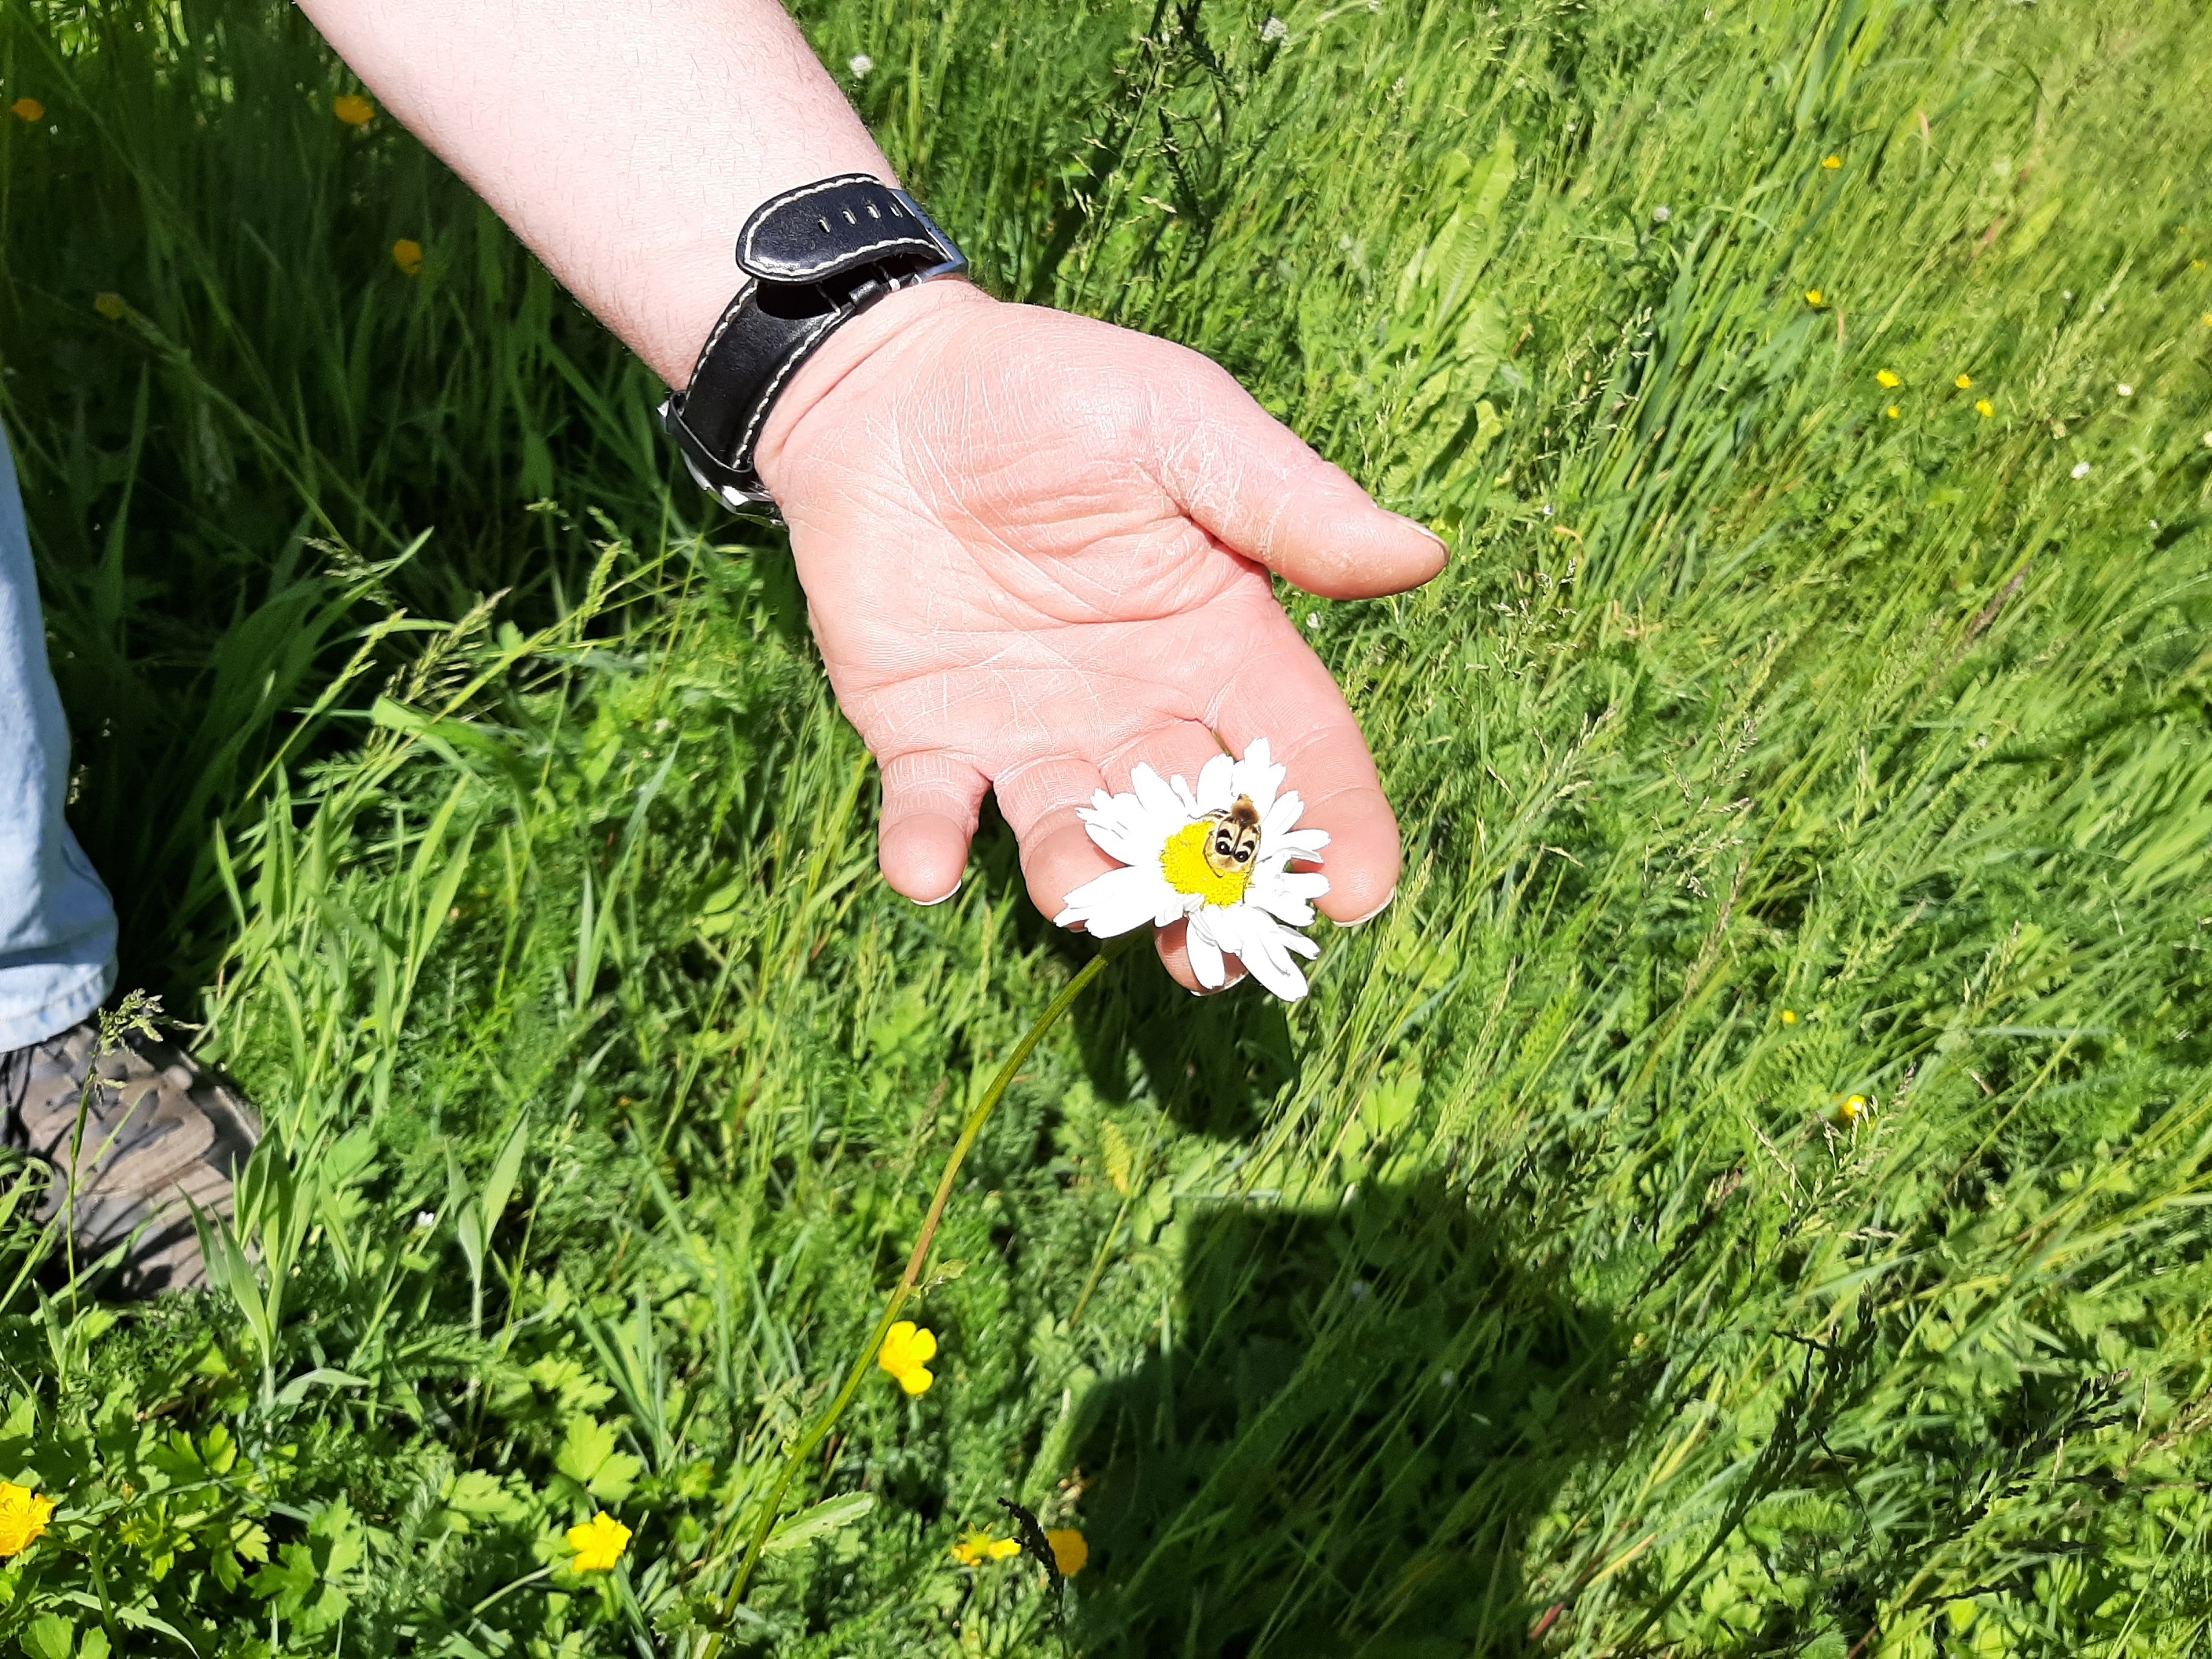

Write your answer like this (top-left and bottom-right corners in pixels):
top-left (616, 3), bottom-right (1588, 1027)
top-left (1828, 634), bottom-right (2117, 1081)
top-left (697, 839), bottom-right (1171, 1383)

top-left (756, 283), bottom-right (1444, 989)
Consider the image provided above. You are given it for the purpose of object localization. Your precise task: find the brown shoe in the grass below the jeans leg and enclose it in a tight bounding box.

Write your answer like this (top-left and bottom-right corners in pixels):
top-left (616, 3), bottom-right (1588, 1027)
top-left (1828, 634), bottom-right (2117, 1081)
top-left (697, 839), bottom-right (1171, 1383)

top-left (0, 1016), bottom-right (261, 1296)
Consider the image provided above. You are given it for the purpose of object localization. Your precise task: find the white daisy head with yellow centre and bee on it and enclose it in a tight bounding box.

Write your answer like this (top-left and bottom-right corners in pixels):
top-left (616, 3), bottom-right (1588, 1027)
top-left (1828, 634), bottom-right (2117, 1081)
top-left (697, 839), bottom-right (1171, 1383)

top-left (1053, 739), bottom-right (1330, 1002)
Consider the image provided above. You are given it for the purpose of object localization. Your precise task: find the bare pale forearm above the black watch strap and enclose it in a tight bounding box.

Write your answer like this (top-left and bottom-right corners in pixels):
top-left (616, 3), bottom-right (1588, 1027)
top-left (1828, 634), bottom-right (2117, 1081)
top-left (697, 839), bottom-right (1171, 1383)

top-left (301, 0), bottom-right (896, 387)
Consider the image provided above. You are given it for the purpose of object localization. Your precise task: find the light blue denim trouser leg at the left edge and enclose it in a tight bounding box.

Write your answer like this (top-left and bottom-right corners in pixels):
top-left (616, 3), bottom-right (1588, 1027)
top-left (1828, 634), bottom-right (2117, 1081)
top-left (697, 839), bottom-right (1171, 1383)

top-left (0, 433), bottom-right (115, 1053)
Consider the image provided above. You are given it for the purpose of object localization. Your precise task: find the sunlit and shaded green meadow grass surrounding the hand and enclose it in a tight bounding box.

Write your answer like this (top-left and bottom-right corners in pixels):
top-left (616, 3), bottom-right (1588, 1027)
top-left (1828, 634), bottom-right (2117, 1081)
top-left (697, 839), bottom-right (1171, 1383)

top-left (0, 0), bottom-right (2212, 1659)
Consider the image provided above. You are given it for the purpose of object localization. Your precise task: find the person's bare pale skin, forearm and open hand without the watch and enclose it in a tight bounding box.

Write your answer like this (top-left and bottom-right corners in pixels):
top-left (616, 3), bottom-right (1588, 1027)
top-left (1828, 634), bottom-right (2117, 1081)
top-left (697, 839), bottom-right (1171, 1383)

top-left (301, 0), bottom-right (1444, 989)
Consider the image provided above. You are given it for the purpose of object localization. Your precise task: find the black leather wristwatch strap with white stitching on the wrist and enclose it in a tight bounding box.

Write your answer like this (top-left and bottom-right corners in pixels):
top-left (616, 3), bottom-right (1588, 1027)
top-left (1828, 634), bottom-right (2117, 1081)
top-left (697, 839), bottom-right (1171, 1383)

top-left (661, 172), bottom-right (967, 511)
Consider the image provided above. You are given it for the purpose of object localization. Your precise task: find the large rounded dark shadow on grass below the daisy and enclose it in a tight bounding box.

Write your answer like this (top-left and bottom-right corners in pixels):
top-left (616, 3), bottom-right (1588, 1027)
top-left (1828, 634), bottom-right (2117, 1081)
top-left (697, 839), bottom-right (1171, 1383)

top-left (1077, 1183), bottom-right (1635, 1659)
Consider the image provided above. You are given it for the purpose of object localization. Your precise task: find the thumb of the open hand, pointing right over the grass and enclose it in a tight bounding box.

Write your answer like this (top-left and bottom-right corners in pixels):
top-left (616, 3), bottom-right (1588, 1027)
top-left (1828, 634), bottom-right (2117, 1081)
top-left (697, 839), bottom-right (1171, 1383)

top-left (1153, 347), bottom-right (1449, 599)
